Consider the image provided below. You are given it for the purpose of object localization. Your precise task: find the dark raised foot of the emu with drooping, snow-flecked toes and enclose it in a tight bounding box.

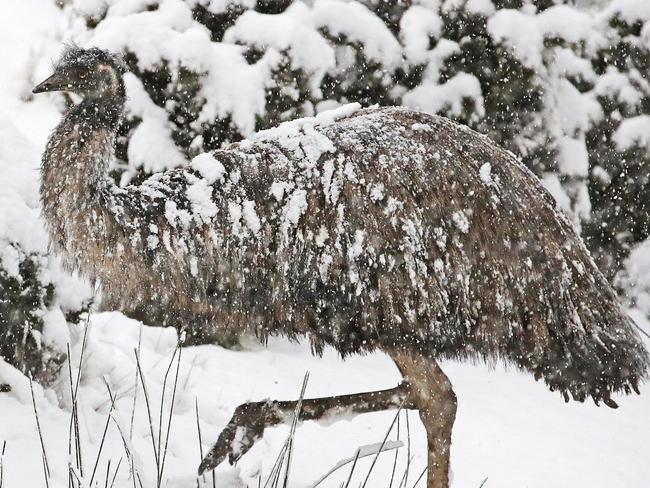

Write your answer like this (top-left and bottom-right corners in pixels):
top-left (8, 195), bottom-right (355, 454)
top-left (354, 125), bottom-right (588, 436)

top-left (199, 401), bottom-right (280, 475)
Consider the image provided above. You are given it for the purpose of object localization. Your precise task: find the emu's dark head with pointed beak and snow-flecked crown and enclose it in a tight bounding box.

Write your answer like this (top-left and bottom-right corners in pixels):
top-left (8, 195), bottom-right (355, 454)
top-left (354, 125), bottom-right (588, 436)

top-left (32, 45), bottom-right (126, 100)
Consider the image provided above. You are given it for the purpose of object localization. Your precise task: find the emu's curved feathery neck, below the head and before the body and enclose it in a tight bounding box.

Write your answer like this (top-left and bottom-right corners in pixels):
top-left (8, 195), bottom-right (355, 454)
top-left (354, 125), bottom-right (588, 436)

top-left (41, 97), bottom-right (124, 275)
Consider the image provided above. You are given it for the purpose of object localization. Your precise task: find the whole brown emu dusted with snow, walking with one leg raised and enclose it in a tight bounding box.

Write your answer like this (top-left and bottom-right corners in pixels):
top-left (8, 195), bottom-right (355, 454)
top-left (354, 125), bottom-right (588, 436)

top-left (33, 46), bottom-right (649, 488)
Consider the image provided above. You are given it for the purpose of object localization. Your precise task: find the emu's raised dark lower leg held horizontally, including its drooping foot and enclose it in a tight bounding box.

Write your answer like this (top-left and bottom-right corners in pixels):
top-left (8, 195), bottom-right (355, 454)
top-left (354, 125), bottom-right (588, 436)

top-left (199, 382), bottom-right (416, 474)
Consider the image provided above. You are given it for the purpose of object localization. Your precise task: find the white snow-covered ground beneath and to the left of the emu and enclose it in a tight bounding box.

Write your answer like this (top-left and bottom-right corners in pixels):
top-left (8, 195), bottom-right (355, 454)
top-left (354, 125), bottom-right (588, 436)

top-left (0, 0), bottom-right (650, 488)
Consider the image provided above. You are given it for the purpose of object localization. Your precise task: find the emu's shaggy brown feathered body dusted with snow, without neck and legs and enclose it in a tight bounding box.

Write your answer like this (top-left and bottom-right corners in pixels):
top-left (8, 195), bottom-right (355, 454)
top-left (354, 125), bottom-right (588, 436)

top-left (107, 108), bottom-right (648, 401)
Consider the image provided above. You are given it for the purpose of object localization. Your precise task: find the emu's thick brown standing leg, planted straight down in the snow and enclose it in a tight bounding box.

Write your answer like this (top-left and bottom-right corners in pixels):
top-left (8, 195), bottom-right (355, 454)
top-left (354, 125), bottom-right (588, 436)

top-left (389, 352), bottom-right (456, 488)
